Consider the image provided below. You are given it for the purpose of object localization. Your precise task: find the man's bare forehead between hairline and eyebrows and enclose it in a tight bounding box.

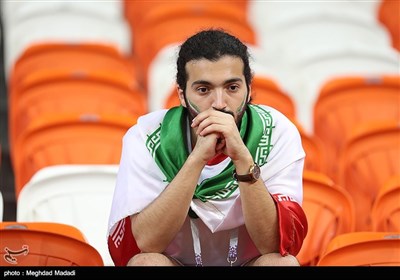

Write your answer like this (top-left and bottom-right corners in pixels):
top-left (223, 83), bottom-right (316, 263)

top-left (186, 56), bottom-right (244, 82)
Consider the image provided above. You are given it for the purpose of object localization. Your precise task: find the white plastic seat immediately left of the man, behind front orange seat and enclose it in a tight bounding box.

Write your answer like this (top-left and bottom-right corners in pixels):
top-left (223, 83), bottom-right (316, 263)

top-left (17, 164), bottom-right (118, 266)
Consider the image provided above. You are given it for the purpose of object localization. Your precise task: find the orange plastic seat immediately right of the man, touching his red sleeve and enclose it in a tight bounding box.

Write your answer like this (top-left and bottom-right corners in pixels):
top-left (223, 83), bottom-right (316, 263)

top-left (297, 170), bottom-right (355, 266)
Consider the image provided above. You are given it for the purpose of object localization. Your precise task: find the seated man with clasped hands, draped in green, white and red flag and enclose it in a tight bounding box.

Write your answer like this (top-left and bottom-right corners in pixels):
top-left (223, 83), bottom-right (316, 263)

top-left (108, 29), bottom-right (307, 266)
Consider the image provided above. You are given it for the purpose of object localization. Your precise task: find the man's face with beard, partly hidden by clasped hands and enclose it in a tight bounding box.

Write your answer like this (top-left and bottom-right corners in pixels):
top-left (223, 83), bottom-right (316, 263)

top-left (179, 56), bottom-right (250, 123)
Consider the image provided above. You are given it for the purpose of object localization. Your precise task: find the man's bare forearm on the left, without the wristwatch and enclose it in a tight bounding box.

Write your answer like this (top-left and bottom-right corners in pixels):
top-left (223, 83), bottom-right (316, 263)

top-left (131, 153), bottom-right (204, 253)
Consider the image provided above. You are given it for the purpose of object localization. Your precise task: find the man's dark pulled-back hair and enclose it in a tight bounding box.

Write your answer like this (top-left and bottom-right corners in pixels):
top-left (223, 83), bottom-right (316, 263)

top-left (176, 29), bottom-right (252, 92)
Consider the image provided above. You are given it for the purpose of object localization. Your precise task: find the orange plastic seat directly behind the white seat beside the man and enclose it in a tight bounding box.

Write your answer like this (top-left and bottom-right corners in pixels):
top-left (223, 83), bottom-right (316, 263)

top-left (13, 114), bottom-right (136, 197)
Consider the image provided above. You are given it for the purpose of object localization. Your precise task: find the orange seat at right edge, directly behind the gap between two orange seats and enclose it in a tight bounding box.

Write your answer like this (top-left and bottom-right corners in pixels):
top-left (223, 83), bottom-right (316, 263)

top-left (337, 119), bottom-right (400, 231)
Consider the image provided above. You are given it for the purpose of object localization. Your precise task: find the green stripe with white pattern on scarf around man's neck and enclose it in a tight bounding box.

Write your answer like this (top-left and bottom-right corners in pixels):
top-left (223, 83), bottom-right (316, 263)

top-left (146, 105), bottom-right (273, 201)
